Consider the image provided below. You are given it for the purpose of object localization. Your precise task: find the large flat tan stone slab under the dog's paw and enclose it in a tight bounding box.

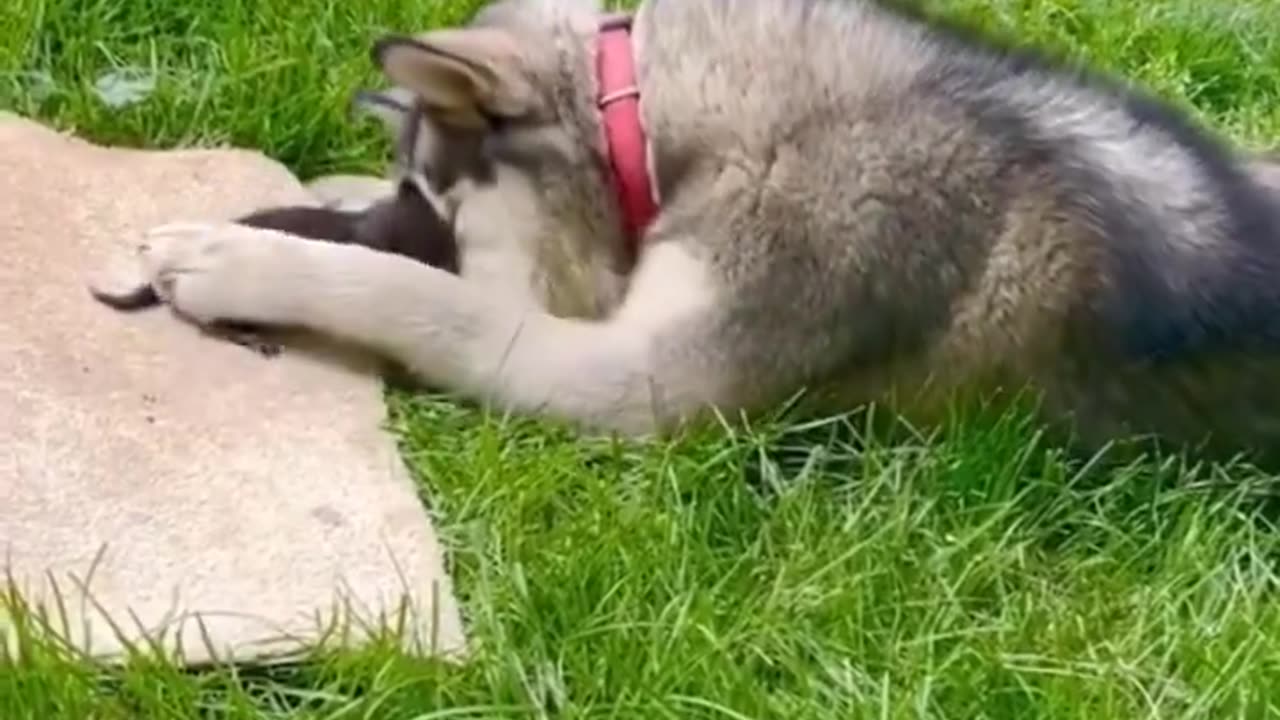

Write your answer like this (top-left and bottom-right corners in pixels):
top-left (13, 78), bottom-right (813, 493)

top-left (0, 114), bottom-right (463, 664)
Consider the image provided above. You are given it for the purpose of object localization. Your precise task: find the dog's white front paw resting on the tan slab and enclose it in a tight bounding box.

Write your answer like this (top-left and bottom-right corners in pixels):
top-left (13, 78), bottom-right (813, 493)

top-left (138, 223), bottom-right (302, 325)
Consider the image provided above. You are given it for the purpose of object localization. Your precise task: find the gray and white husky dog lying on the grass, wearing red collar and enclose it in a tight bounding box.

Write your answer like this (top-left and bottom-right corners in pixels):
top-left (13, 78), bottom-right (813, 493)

top-left (104, 0), bottom-right (1280, 452)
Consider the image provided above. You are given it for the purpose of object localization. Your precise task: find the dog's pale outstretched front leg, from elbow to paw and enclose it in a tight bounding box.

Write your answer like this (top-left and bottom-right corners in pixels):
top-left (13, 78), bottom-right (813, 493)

top-left (142, 224), bottom-right (714, 433)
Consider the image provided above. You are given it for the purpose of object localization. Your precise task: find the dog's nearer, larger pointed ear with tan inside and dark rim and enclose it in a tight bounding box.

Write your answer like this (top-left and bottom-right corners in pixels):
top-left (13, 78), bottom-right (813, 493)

top-left (372, 28), bottom-right (534, 129)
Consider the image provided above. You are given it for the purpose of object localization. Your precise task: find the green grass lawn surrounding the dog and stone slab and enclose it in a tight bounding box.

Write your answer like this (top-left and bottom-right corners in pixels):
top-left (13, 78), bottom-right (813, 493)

top-left (0, 0), bottom-right (1280, 720)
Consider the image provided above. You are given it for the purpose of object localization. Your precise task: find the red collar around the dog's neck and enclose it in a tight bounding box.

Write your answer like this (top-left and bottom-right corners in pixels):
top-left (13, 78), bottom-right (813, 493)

top-left (596, 15), bottom-right (658, 256)
